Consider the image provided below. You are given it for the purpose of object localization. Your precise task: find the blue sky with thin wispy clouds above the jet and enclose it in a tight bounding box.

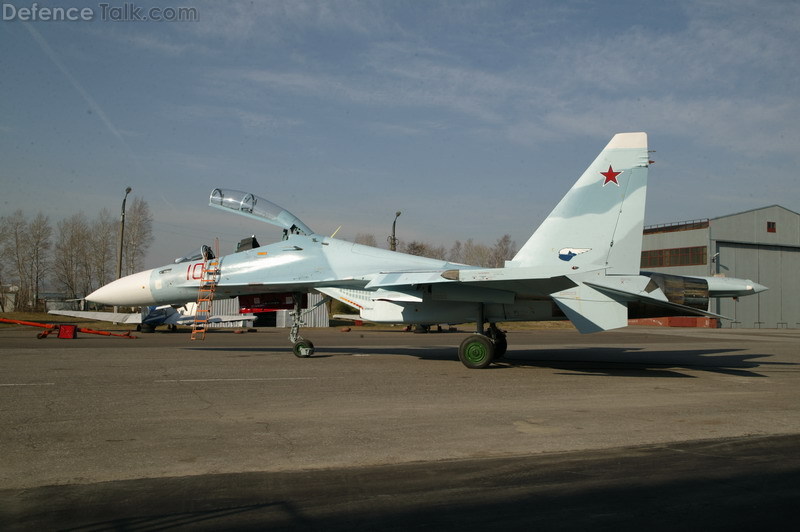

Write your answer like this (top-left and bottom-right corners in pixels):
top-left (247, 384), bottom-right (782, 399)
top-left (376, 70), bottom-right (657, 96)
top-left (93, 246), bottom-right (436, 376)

top-left (0, 0), bottom-right (800, 267)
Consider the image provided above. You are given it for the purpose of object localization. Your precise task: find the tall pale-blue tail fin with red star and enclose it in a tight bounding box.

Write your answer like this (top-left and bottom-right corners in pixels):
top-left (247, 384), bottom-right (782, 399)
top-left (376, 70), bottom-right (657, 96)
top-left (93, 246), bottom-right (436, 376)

top-left (507, 133), bottom-right (648, 274)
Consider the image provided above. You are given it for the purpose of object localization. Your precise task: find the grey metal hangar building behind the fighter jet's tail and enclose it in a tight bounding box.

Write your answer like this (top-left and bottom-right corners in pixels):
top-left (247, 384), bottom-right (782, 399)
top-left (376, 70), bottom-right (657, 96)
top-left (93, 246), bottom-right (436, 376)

top-left (642, 205), bottom-right (800, 329)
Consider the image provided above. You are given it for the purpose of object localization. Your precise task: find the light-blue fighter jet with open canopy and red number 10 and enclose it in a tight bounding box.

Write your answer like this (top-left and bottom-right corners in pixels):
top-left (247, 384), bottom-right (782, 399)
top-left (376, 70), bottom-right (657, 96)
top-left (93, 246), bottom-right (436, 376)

top-left (86, 133), bottom-right (766, 368)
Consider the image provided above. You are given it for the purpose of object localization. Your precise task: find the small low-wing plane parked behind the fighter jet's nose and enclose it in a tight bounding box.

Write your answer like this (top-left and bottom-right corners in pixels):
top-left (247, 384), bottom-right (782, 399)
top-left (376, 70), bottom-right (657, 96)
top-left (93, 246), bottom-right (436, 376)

top-left (49, 302), bottom-right (255, 333)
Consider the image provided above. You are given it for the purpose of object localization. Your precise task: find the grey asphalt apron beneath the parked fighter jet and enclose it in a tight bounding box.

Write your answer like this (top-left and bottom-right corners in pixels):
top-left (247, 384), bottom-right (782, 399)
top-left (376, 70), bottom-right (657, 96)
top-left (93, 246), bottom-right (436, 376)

top-left (0, 328), bottom-right (800, 530)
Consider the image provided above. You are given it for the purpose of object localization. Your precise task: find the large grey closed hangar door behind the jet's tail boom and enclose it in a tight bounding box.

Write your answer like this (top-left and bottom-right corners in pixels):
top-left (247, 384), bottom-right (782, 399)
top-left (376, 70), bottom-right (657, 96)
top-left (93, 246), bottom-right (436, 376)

top-left (716, 242), bottom-right (800, 329)
